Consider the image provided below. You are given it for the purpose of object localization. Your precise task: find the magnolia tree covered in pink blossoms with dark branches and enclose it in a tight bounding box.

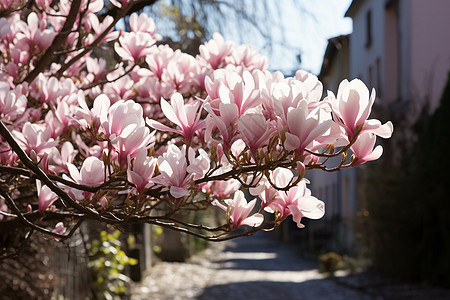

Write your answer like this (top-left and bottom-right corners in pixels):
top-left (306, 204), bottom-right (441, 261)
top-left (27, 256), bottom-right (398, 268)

top-left (0, 0), bottom-right (393, 248)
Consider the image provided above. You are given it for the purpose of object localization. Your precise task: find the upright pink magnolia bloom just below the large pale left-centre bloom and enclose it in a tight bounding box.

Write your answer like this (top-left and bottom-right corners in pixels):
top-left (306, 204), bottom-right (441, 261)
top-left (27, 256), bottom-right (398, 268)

top-left (127, 149), bottom-right (156, 193)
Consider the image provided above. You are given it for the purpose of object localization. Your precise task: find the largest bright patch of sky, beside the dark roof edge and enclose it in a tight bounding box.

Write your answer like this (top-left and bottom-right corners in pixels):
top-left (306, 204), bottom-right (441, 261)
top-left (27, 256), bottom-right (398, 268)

top-left (243, 0), bottom-right (352, 75)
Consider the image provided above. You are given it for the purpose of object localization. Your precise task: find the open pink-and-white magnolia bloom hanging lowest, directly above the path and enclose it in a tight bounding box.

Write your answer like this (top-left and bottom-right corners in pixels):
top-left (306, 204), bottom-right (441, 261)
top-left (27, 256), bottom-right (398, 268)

top-left (212, 191), bottom-right (264, 230)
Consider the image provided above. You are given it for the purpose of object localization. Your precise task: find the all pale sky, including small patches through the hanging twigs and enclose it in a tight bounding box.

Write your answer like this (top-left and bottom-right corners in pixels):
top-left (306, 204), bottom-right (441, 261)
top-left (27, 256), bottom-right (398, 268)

top-left (142, 0), bottom-right (352, 75)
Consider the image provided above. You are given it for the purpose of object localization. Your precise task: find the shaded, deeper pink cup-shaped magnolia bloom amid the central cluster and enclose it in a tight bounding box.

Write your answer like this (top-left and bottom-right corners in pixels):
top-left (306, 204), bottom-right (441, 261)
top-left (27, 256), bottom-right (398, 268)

top-left (238, 114), bottom-right (276, 154)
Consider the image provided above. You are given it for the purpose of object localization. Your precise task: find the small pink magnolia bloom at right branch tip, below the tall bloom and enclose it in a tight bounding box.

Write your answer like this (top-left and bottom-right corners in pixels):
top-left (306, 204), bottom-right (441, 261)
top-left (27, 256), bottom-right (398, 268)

top-left (350, 132), bottom-right (383, 166)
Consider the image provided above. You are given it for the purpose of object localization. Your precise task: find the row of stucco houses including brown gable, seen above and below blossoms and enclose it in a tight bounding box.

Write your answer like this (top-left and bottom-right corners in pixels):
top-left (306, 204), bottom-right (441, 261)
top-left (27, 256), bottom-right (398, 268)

top-left (311, 0), bottom-right (450, 252)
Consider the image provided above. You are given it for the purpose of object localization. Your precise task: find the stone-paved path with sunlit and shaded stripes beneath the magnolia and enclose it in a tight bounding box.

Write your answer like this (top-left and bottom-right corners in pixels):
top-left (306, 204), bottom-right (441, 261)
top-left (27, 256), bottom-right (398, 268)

top-left (131, 233), bottom-right (450, 300)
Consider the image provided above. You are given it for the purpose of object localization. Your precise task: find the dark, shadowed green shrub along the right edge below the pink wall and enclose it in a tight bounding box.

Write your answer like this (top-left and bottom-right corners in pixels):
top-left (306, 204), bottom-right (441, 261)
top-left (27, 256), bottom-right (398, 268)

top-left (362, 70), bottom-right (450, 286)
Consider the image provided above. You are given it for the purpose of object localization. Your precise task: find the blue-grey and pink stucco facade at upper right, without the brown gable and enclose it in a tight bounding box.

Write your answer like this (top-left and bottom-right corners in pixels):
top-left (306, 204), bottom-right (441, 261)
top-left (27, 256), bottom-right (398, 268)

top-left (346, 0), bottom-right (450, 113)
